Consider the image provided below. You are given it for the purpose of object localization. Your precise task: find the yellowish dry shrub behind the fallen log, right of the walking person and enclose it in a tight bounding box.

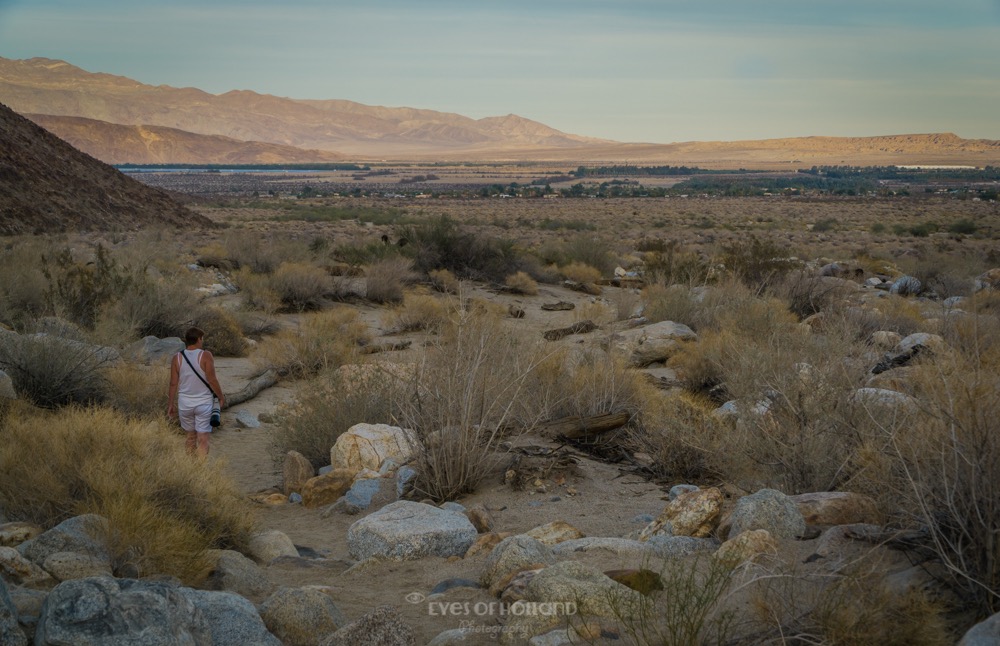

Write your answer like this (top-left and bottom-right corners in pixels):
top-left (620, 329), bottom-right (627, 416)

top-left (258, 307), bottom-right (369, 378)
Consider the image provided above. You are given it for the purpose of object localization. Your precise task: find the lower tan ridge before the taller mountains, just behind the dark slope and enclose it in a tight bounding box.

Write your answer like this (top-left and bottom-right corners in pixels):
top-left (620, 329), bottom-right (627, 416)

top-left (25, 114), bottom-right (344, 164)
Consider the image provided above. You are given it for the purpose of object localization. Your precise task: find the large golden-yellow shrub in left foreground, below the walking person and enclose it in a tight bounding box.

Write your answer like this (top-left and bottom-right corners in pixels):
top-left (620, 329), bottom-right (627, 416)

top-left (0, 408), bottom-right (253, 583)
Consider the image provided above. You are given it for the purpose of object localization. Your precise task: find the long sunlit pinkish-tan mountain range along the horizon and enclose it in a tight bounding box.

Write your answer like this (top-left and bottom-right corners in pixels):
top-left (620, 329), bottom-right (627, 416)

top-left (0, 58), bottom-right (1000, 169)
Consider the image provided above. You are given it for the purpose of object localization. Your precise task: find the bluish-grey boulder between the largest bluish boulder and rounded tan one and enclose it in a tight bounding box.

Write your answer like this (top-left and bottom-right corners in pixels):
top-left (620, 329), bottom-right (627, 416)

top-left (178, 588), bottom-right (282, 646)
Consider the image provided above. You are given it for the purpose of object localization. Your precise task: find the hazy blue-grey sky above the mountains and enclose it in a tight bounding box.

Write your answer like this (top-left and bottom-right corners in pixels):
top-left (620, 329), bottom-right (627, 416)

top-left (0, 0), bottom-right (1000, 143)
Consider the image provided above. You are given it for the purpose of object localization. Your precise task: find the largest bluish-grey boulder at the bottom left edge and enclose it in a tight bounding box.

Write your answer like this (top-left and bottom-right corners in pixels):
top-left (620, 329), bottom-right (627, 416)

top-left (36, 577), bottom-right (212, 646)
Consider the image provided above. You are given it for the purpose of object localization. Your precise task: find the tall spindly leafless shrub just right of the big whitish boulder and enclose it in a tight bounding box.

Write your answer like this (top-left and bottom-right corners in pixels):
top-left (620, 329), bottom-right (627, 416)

top-left (400, 310), bottom-right (543, 501)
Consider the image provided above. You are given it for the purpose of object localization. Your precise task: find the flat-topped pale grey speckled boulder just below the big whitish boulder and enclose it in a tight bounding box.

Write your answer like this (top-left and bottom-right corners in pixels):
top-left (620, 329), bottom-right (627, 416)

top-left (347, 500), bottom-right (478, 561)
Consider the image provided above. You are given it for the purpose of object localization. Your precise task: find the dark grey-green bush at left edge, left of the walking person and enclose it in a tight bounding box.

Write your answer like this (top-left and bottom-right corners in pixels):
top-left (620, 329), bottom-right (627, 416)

top-left (0, 334), bottom-right (114, 408)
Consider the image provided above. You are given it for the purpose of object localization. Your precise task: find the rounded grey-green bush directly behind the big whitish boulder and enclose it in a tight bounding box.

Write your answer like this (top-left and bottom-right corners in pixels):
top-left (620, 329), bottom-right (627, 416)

top-left (271, 363), bottom-right (410, 468)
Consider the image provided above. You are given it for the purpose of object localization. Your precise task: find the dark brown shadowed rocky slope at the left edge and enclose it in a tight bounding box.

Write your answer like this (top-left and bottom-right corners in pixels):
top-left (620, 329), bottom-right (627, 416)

top-left (0, 104), bottom-right (209, 235)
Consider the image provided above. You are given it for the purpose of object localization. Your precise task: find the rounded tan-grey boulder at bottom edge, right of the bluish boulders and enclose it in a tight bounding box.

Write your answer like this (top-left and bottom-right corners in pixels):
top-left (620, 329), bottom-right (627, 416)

top-left (260, 588), bottom-right (347, 646)
